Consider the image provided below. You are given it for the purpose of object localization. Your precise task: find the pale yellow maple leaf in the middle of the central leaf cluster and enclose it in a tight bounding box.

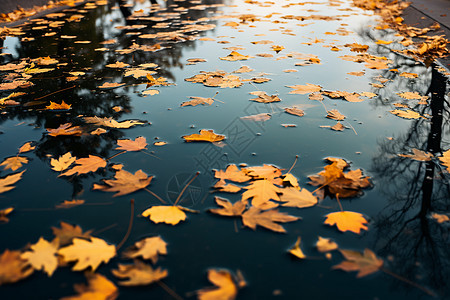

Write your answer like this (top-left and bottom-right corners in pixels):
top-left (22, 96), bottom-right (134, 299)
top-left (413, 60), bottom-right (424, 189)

top-left (242, 179), bottom-right (282, 209)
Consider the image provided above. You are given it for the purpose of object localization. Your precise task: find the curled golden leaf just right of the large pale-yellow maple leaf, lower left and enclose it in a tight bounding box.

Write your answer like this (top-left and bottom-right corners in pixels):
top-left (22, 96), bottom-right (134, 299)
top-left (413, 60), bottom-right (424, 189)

top-left (124, 236), bottom-right (167, 264)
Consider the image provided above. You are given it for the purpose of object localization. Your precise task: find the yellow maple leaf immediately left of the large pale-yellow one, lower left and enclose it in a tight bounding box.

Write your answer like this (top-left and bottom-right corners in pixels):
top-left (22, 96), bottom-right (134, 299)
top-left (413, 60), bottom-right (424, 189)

top-left (20, 237), bottom-right (59, 277)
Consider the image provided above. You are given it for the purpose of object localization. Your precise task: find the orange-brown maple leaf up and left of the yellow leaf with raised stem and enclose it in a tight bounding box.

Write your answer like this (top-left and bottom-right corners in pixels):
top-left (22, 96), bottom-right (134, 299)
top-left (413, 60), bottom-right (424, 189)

top-left (93, 170), bottom-right (153, 197)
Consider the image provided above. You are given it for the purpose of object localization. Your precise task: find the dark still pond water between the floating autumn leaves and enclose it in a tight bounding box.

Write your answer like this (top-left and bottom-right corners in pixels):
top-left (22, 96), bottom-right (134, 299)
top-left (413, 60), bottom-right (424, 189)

top-left (0, 1), bottom-right (450, 299)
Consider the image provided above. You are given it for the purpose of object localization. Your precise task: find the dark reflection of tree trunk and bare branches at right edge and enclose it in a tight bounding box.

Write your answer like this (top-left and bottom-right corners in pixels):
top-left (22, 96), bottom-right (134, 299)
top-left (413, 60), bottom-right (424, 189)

top-left (373, 62), bottom-right (450, 296)
